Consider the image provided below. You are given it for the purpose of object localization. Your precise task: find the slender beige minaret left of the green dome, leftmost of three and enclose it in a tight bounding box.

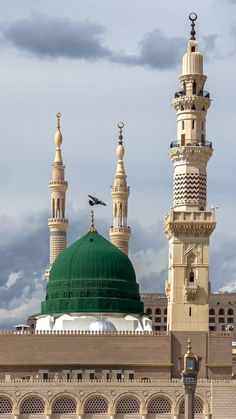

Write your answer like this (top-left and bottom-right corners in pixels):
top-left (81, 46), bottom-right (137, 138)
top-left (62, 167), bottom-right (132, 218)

top-left (45, 112), bottom-right (68, 279)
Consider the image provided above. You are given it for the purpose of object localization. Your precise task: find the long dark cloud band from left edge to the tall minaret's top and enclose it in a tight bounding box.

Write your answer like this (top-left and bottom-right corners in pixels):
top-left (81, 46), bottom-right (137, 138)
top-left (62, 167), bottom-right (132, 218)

top-left (0, 14), bottom-right (186, 69)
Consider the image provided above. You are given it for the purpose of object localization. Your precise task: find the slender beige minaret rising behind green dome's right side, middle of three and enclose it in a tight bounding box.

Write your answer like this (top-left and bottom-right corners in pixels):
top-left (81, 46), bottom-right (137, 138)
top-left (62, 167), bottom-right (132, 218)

top-left (110, 122), bottom-right (131, 255)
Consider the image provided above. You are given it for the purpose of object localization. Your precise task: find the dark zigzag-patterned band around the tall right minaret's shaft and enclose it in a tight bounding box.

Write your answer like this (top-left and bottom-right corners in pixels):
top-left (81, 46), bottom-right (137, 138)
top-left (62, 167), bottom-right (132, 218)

top-left (174, 173), bottom-right (206, 207)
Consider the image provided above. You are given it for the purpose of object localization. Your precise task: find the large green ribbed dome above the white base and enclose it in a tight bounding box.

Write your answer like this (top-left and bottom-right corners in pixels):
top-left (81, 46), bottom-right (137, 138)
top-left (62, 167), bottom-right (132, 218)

top-left (41, 231), bottom-right (144, 315)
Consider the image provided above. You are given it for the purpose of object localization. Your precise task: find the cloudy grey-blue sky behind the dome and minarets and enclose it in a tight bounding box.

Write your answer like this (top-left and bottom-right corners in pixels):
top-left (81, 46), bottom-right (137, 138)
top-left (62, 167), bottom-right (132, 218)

top-left (0, 0), bottom-right (236, 328)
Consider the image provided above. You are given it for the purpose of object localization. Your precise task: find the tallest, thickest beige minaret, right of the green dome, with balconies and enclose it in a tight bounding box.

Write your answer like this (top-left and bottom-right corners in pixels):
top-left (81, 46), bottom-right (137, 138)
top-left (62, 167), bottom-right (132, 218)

top-left (164, 13), bottom-right (215, 331)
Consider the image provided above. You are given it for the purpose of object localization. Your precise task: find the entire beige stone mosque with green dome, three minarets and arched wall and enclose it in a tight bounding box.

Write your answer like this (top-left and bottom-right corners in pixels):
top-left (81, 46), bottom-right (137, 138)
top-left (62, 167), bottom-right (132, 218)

top-left (0, 13), bottom-right (236, 419)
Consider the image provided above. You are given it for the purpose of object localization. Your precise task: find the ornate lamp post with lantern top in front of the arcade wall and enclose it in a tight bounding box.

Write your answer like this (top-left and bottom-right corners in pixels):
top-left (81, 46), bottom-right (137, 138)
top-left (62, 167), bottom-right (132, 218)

top-left (181, 339), bottom-right (199, 419)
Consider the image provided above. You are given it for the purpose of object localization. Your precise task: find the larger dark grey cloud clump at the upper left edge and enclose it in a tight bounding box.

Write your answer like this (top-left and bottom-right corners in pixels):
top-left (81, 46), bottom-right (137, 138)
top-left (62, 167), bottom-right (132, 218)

top-left (0, 14), bottom-right (110, 60)
